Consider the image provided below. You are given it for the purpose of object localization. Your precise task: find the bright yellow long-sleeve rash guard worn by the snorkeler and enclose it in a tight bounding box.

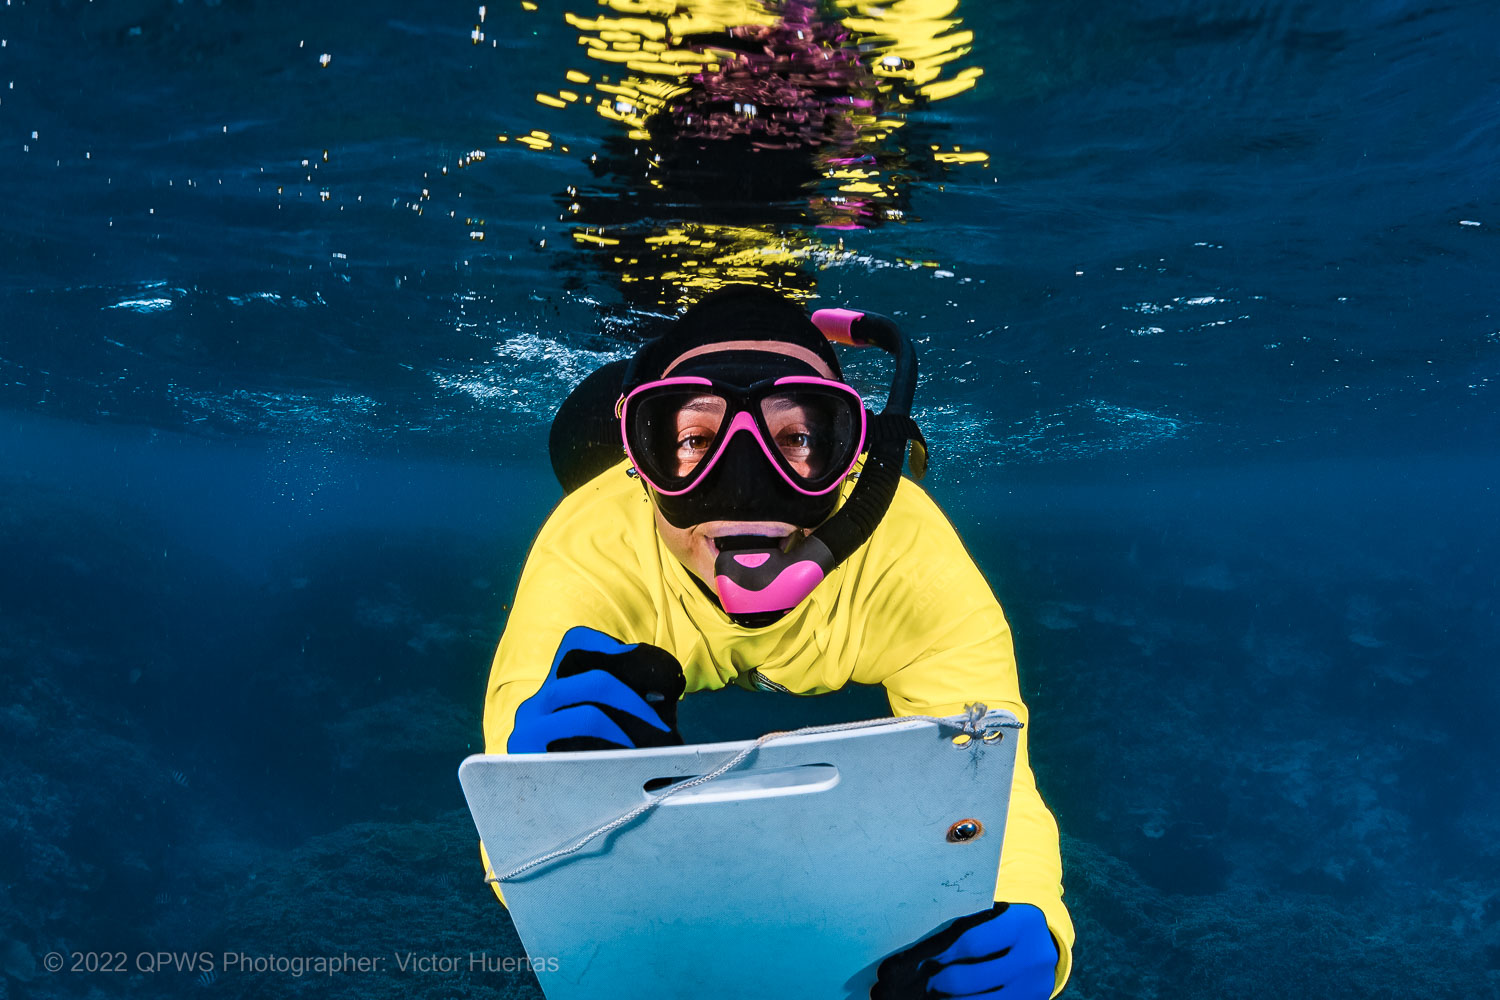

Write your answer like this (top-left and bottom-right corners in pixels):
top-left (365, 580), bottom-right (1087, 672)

top-left (485, 463), bottom-right (1074, 996)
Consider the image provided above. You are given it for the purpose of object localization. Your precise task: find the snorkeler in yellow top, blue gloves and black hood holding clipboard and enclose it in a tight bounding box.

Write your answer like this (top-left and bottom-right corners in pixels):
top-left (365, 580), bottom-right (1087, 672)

top-left (485, 285), bottom-right (1074, 1000)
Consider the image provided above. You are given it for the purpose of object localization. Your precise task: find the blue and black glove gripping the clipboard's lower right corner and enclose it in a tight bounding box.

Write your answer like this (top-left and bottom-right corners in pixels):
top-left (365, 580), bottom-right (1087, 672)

top-left (870, 903), bottom-right (1058, 1000)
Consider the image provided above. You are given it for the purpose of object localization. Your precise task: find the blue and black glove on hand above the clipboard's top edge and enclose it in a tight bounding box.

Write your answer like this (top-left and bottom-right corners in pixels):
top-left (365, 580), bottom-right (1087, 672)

top-left (506, 627), bottom-right (687, 754)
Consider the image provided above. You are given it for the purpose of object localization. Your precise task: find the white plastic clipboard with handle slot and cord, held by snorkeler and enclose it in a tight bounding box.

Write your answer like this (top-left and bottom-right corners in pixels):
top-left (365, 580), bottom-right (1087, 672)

top-left (459, 711), bottom-right (1020, 1000)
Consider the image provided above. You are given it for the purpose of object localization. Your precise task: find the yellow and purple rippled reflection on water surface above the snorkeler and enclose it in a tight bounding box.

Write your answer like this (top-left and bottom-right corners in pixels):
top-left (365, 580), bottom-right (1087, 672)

top-left (486, 0), bottom-right (990, 306)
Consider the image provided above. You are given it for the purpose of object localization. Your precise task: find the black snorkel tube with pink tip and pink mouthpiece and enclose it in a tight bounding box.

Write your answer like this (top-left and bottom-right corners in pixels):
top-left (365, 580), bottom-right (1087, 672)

top-left (714, 309), bottom-right (927, 628)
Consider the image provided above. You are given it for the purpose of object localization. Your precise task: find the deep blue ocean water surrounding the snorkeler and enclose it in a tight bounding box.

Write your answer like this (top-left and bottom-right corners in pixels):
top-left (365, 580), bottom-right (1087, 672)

top-left (0, 0), bottom-right (1500, 999)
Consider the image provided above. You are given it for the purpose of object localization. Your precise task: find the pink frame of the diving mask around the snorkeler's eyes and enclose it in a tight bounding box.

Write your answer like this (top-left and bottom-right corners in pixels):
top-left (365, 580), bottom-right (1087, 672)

top-left (615, 375), bottom-right (869, 496)
